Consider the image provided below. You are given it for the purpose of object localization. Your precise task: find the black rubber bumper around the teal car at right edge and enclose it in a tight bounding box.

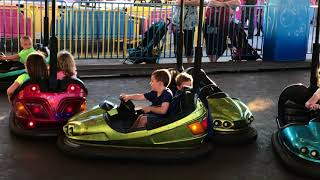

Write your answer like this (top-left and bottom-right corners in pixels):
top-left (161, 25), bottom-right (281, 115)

top-left (271, 131), bottom-right (320, 179)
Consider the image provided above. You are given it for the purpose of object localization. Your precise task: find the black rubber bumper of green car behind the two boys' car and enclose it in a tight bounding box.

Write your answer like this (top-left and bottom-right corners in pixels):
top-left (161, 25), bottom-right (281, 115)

top-left (211, 127), bottom-right (258, 145)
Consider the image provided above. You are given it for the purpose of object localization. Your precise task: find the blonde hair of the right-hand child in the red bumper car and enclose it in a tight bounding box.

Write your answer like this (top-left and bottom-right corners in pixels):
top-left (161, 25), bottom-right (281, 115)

top-left (57, 51), bottom-right (77, 77)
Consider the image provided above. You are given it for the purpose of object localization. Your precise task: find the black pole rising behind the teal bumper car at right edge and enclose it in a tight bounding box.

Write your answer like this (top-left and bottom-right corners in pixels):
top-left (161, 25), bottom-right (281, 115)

top-left (310, 0), bottom-right (320, 92)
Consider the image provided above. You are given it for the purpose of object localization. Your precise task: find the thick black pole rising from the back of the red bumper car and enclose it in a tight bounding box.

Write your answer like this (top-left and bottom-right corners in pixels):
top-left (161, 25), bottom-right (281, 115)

top-left (49, 0), bottom-right (58, 91)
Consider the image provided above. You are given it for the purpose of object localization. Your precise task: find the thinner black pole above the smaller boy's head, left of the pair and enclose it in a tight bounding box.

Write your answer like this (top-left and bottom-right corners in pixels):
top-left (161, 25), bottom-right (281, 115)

top-left (177, 0), bottom-right (184, 72)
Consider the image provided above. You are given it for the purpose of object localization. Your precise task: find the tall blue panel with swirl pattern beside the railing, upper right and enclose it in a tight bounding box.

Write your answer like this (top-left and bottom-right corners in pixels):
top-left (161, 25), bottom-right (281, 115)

top-left (263, 0), bottom-right (310, 61)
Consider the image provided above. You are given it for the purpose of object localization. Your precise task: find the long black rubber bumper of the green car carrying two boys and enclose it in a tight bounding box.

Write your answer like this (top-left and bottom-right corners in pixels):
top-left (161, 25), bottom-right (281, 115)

top-left (57, 135), bottom-right (212, 161)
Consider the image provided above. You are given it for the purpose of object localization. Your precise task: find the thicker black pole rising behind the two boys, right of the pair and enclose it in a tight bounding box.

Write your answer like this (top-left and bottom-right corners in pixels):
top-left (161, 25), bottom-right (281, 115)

top-left (193, 0), bottom-right (204, 91)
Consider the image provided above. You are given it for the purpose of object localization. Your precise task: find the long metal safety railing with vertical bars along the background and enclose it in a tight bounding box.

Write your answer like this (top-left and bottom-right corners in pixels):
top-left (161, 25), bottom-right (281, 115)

top-left (0, 0), bottom-right (316, 61)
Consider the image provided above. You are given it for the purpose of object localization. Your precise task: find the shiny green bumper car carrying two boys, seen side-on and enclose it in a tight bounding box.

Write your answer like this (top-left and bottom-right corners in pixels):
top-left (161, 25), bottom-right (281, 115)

top-left (57, 88), bottom-right (211, 160)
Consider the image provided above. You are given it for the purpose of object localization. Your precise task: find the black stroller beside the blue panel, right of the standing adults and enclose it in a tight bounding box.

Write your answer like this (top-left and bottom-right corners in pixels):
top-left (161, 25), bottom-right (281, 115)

top-left (228, 22), bottom-right (261, 61)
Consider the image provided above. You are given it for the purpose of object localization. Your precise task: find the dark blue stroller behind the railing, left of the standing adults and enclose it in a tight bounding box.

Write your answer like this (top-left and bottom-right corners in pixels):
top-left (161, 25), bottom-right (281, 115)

top-left (123, 19), bottom-right (170, 64)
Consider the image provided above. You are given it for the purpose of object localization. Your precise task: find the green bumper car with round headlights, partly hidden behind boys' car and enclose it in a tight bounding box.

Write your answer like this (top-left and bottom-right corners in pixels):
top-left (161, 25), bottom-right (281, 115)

top-left (185, 68), bottom-right (257, 144)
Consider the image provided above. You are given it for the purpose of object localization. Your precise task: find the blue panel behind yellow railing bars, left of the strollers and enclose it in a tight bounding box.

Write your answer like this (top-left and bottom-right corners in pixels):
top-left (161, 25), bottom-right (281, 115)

top-left (56, 10), bottom-right (134, 40)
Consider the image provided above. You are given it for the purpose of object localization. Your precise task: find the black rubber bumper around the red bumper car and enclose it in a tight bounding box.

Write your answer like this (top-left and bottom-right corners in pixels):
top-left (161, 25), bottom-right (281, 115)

top-left (9, 112), bottom-right (62, 138)
